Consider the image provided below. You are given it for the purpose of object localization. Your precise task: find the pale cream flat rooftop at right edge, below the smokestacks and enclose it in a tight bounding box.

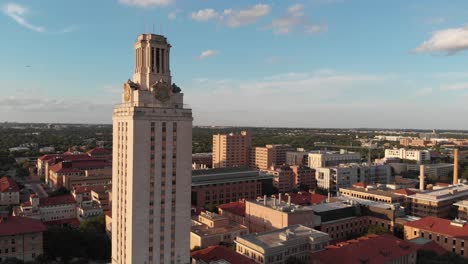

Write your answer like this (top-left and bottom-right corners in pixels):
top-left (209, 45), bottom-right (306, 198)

top-left (408, 184), bottom-right (468, 202)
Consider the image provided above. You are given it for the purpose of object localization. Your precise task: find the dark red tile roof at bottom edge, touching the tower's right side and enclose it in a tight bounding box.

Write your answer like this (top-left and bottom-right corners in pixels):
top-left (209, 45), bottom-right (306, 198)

top-left (190, 246), bottom-right (256, 264)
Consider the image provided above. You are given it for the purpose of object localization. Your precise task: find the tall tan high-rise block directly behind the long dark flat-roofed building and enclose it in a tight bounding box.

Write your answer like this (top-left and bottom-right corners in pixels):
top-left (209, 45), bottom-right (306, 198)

top-left (213, 131), bottom-right (252, 168)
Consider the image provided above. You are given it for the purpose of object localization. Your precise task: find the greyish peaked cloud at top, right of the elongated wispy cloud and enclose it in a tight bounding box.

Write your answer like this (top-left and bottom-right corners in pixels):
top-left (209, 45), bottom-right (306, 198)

top-left (265, 4), bottom-right (328, 35)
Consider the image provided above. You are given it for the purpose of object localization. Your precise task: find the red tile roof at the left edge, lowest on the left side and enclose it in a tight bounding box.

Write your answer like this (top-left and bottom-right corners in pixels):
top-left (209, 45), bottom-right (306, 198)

top-left (0, 216), bottom-right (46, 236)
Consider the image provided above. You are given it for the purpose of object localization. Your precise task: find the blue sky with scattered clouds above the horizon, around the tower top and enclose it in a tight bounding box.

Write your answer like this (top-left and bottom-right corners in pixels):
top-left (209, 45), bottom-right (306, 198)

top-left (0, 0), bottom-right (468, 129)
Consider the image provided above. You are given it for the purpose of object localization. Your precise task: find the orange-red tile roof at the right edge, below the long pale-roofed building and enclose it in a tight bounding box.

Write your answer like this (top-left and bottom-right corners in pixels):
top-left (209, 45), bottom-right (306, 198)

top-left (405, 216), bottom-right (468, 239)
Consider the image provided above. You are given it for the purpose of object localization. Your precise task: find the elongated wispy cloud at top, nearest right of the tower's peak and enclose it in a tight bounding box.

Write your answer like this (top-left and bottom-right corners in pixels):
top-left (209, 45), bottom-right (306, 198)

top-left (191, 4), bottom-right (271, 28)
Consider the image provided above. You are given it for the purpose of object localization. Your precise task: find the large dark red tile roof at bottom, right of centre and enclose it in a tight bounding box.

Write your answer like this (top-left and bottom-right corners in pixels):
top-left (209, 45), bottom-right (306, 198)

top-left (311, 234), bottom-right (418, 264)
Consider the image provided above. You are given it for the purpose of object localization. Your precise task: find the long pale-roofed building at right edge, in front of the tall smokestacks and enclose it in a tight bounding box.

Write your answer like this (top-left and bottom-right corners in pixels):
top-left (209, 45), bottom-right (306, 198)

top-left (408, 184), bottom-right (468, 218)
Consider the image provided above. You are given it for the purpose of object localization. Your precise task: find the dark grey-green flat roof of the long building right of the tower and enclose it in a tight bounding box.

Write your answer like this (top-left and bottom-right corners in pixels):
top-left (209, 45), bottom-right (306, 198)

top-left (192, 168), bottom-right (273, 186)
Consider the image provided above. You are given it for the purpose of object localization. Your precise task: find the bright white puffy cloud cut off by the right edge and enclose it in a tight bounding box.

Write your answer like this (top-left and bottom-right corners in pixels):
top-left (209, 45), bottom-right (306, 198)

top-left (415, 26), bottom-right (468, 54)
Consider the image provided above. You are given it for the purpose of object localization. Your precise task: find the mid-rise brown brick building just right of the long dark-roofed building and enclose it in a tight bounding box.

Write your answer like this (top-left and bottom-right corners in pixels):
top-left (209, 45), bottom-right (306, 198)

top-left (262, 165), bottom-right (317, 192)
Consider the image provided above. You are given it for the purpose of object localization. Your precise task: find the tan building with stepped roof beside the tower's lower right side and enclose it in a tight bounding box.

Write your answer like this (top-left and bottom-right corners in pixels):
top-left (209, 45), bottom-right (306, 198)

top-left (190, 212), bottom-right (249, 249)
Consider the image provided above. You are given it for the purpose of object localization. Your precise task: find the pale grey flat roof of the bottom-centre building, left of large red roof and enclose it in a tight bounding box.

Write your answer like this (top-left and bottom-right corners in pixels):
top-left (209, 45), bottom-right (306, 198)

top-left (236, 225), bottom-right (328, 249)
